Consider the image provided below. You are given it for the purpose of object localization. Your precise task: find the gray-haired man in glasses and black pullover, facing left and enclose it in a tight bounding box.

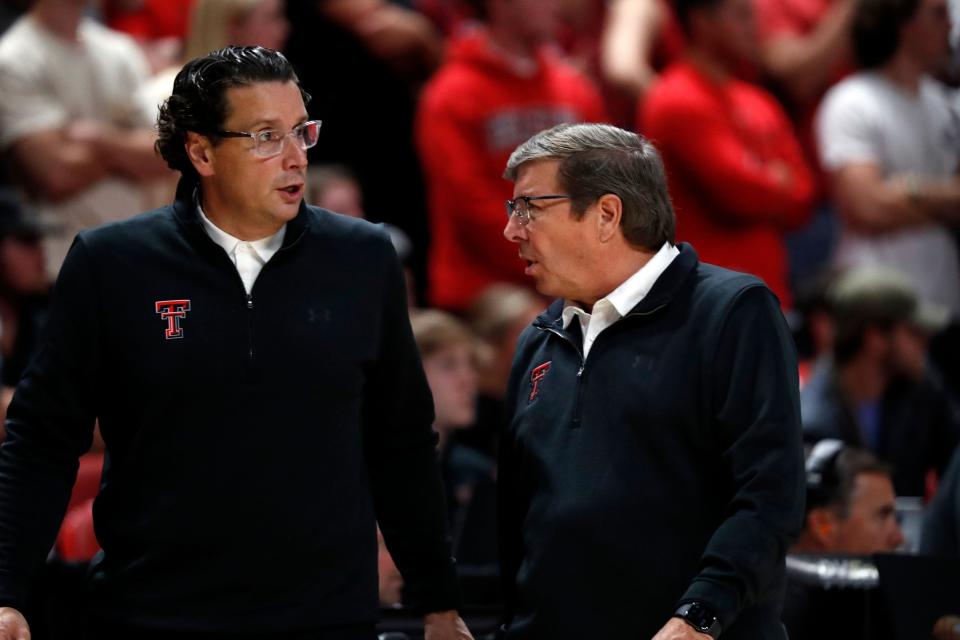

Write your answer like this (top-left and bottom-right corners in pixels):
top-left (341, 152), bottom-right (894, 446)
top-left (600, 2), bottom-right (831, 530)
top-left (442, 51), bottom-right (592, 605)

top-left (498, 124), bottom-right (804, 640)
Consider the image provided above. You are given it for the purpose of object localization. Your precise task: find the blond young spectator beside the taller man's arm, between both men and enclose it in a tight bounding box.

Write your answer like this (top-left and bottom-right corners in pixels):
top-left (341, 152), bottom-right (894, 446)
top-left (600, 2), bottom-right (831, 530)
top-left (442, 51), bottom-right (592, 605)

top-left (410, 309), bottom-right (494, 546)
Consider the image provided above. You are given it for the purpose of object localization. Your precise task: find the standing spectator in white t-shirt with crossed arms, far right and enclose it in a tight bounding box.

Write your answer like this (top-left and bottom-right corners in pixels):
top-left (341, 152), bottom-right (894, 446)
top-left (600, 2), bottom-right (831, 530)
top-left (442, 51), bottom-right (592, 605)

top-left (817, 0), bottom-right (960, 318)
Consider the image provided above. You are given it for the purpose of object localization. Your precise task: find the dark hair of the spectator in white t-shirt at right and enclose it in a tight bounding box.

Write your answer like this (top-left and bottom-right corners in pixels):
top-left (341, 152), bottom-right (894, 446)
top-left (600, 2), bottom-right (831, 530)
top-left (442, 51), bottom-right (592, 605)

top-left (851, 0), bottom-right (920, 69)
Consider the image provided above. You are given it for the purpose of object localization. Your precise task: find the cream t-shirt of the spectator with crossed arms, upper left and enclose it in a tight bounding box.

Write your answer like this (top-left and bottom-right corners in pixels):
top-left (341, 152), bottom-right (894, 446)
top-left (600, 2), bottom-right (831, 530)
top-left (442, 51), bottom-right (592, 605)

top-left (0, 13), bottom-right (156, 276)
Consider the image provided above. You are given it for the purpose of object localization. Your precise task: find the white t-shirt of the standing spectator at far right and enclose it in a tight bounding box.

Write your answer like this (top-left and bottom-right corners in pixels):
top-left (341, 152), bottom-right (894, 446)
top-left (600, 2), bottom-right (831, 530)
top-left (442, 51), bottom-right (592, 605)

top-left (817, 71), bottom-right (960, 318)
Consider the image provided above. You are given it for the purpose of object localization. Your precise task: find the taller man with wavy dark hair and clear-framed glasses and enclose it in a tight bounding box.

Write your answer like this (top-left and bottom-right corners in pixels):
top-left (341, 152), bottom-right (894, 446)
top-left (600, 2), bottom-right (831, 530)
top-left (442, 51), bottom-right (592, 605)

top-left (0, 47), bottom-right (470, 640)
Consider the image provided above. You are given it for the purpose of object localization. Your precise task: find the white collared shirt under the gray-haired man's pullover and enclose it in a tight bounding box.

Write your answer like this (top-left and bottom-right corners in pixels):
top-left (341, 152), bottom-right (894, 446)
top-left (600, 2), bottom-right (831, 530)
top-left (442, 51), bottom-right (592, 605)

top-left (562, 242), bottom-right (680, 360)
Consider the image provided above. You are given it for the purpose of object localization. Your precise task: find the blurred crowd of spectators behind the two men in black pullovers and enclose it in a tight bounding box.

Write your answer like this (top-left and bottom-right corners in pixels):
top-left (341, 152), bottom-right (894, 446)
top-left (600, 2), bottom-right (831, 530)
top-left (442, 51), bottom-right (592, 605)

top-left (0, 0), bottom-right (960, 638)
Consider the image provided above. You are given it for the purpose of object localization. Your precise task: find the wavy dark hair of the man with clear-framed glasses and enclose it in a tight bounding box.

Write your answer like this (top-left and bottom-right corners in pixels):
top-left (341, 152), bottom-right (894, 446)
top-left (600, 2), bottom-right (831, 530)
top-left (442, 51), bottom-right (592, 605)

top-left (156, 47), bottom-right (310, 180)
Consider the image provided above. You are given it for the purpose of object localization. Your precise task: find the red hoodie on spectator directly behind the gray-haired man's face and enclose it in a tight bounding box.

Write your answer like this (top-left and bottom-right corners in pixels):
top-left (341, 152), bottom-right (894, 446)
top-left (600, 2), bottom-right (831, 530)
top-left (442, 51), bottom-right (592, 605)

top-left (416, 30), bottom-right (606, 310)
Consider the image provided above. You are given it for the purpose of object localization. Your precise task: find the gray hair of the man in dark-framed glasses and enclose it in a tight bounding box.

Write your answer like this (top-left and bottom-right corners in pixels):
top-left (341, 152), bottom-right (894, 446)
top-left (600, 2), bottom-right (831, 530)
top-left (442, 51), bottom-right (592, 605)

top-left (503, 124), bottom-right (676, 251)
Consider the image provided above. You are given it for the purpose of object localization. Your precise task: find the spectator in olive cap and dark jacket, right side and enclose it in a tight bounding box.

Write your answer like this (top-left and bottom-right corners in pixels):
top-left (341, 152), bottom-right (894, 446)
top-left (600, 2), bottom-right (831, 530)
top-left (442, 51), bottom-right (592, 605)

top-left (800, 268), bottom-right (960, 496)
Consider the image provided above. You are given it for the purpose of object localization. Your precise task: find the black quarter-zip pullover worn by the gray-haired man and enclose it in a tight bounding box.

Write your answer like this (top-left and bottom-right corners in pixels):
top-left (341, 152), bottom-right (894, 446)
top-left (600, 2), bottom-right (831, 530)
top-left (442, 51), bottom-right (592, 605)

top-left (499, 245), bottom-right (804, 640)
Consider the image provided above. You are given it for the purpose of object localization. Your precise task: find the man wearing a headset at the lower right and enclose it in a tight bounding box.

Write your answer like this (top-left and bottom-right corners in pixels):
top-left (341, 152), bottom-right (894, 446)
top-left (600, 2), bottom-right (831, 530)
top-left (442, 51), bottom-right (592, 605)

top-left (782, 440), bottom-right (904, 640)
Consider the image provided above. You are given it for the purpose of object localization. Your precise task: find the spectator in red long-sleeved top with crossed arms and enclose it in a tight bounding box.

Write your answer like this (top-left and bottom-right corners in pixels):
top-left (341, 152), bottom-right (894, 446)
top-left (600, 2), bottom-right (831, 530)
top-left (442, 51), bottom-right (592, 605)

top-left (640, 0), bottom-right (814, 308)
